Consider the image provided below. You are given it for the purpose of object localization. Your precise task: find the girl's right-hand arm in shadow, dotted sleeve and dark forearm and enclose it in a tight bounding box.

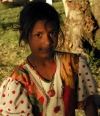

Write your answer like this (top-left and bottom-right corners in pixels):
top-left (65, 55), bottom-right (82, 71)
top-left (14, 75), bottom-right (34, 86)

top-left (78, 57), bottom-right (98, 116)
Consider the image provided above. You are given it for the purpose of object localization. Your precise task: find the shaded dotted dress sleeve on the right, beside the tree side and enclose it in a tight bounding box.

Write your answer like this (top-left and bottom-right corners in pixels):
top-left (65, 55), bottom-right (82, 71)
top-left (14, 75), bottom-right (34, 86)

top-left (78, 57), bottom-right (96, 101)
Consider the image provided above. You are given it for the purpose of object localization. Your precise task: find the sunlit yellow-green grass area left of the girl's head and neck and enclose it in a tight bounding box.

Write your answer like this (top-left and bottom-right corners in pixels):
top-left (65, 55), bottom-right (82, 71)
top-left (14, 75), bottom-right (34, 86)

top-left (0, 4), bottom-right (28, 80)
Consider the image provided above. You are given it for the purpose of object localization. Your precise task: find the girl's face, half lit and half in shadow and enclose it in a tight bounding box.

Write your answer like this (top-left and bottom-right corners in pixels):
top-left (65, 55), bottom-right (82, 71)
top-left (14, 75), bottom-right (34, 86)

top-left (29, 20), bottom-right (58, 58)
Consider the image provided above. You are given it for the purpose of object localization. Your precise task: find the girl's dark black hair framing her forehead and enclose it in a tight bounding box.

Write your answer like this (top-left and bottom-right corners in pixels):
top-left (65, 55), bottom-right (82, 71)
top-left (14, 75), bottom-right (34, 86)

top-left (19, 1), bottom-right (60, 45)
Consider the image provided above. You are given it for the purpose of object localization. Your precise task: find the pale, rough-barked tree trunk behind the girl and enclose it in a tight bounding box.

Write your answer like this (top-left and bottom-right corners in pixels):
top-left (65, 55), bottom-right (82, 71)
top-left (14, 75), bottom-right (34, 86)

top-left (62, 0), bottom-right (97, 54)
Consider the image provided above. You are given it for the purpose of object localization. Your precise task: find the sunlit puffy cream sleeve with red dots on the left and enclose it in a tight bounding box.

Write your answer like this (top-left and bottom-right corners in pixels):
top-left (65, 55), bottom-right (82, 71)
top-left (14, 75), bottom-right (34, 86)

top-left (0, 78), bottom-right (33, 116)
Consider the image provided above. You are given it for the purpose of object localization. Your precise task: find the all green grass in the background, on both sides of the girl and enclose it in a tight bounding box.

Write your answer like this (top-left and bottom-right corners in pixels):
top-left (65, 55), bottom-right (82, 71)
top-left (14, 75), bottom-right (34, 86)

top-left (0, 2), bottom-right (100, 114)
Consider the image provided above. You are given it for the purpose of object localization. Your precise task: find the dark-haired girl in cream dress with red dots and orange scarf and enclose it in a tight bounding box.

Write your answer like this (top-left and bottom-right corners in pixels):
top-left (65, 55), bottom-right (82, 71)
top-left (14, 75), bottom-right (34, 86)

top-left (0, 2), bottom-right (97, 116)
